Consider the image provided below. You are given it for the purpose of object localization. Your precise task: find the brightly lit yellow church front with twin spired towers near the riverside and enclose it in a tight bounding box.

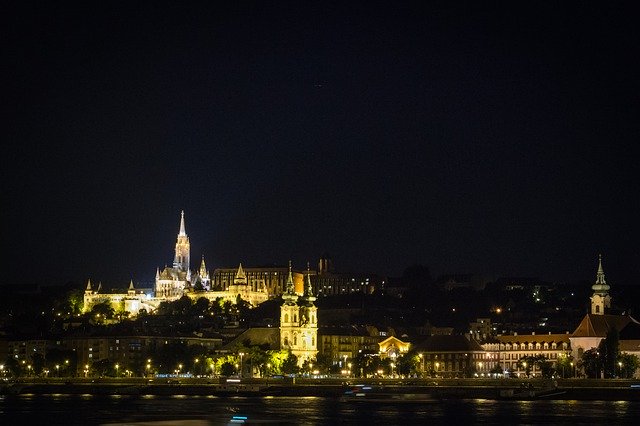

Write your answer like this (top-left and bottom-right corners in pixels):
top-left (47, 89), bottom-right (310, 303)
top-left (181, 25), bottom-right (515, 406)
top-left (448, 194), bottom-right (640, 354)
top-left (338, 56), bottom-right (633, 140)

top-left (280, 262), bottom-right (318, 366)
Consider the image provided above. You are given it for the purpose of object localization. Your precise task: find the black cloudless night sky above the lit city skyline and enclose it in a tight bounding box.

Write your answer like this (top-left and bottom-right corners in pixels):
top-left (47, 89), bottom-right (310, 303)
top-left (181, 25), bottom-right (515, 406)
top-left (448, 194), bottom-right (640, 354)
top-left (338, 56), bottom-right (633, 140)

top-left (0, 1), bottom-right (640, 286)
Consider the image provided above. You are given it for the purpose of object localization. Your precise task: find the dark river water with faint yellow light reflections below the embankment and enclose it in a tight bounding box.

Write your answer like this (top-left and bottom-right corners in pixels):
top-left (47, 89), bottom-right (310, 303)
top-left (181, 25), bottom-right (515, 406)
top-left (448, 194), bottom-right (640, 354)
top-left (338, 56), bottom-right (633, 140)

top-left (0, 395), bottom-right (640, 426)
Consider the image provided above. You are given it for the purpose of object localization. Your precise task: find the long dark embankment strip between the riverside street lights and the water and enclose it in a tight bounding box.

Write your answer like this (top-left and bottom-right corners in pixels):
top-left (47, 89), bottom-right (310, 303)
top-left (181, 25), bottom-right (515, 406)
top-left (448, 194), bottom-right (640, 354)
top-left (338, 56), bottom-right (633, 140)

top-left (0, 378), bottom-right (640, 401)
